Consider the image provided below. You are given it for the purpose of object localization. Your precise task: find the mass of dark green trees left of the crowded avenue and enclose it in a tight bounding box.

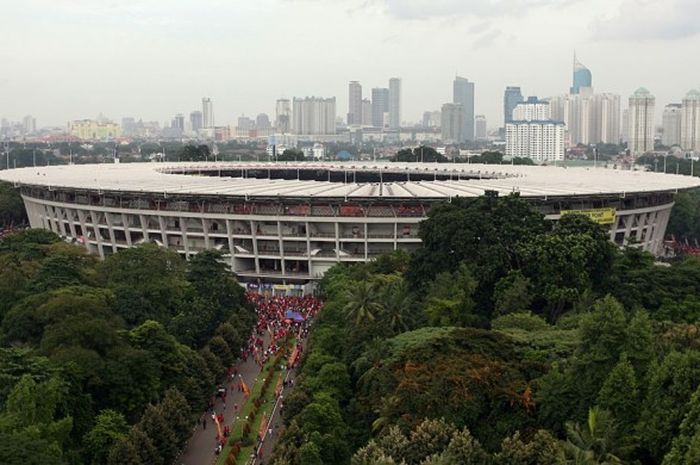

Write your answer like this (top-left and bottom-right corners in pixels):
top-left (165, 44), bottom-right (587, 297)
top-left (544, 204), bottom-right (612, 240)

top-left (0, 230), bottom-right (255, 465)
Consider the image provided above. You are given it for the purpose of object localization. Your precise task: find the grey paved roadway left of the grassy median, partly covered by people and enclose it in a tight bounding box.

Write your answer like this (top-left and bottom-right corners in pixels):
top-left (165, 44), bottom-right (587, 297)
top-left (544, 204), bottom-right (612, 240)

top-left (175, 352), bottom-right (267, 465)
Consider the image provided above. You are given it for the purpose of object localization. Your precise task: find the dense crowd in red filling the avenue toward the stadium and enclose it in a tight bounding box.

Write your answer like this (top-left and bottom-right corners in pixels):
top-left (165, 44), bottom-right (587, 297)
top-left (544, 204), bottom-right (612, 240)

top-left (202, 292), bottom-right (323, 455)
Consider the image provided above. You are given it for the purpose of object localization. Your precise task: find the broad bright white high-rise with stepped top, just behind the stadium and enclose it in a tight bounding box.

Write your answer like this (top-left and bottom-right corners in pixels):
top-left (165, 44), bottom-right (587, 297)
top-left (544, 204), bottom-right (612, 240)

top-left (506, 97), bottom-right (565, 162)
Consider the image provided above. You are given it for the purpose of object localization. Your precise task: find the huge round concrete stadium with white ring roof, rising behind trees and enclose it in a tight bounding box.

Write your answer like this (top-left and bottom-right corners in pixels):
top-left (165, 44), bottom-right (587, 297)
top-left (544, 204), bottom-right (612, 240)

top-left (0, 162), bottom-right (700, 284)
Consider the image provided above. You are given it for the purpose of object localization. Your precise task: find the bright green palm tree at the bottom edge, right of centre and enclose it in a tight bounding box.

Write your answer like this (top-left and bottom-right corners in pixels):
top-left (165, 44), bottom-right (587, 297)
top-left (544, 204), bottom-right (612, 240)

top-left (564, 406), bottom-right (622, 465)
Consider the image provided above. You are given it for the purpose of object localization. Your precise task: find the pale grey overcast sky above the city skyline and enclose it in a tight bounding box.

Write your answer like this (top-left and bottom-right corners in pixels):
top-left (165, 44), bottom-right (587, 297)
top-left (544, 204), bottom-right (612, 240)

top-left (0, 0), bottom-right (700, 127)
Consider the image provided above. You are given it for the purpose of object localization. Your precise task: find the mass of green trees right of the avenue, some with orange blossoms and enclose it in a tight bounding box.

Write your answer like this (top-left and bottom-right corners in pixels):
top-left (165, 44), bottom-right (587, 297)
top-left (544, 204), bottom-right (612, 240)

top-left (270, 195), bottom-right (700, 465)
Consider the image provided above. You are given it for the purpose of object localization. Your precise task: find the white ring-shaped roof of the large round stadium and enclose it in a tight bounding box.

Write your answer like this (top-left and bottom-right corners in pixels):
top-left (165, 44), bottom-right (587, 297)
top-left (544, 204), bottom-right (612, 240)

top-left (0, 162), bottom-right (700, 199)
